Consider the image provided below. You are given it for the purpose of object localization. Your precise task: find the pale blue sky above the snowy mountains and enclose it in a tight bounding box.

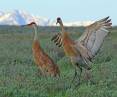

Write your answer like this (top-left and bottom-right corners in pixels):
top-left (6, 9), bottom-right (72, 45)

top-left (0, 0), bottom-right (117, 25)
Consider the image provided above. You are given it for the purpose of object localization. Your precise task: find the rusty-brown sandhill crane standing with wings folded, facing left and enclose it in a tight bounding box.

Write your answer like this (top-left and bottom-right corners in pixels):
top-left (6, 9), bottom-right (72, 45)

top-left (27, 22), bottom-right (60, 76)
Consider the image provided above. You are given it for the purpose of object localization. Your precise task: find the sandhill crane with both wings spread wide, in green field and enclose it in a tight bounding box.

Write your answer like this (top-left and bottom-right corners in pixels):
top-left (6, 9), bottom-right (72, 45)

top-left (52, 17), bottom-right (112, 84)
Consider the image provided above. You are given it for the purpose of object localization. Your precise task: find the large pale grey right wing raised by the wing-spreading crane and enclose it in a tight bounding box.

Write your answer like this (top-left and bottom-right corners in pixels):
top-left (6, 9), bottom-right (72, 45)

top-left (76, 16), bottom-right (112, 58)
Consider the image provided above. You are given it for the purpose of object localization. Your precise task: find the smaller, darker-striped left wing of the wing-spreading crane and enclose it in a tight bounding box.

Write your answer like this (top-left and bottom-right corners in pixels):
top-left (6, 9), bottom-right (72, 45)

top-left (51, 33), bottom-right (62, 47)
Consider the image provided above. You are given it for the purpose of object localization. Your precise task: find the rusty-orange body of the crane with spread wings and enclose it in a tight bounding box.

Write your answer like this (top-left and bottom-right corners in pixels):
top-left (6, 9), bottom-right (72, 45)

top-left (61, 32), bottom-right (90, 71)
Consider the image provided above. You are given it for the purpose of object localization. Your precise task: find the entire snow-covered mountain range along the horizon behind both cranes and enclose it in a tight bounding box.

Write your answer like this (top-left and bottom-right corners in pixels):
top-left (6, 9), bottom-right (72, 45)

top-left (0, 10), bottom-right (92, 26)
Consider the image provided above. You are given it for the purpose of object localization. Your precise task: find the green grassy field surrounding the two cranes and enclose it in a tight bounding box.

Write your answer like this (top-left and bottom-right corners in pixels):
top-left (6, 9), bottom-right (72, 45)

top-left (0, 26), bottom-right (117, 97)
